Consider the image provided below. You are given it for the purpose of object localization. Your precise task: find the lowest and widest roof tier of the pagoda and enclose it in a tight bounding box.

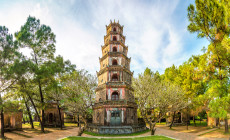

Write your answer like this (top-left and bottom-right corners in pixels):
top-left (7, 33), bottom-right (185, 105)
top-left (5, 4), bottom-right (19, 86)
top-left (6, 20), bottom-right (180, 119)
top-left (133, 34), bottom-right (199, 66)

top-left (93, 100), bottom-right (137, 109)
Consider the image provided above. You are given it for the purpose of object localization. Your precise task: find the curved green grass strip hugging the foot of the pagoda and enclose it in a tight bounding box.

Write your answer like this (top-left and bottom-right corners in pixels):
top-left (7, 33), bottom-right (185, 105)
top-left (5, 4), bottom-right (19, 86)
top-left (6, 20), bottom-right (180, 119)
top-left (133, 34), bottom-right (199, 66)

top-left (84, 129), bottom-right (150, 137)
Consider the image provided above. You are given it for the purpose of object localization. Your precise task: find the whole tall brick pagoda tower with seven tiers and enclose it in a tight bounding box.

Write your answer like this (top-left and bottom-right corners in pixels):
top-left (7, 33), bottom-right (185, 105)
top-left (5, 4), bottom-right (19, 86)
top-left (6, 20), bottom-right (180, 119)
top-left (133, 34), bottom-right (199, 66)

top-left (90, 21), bottom-right (142, 133)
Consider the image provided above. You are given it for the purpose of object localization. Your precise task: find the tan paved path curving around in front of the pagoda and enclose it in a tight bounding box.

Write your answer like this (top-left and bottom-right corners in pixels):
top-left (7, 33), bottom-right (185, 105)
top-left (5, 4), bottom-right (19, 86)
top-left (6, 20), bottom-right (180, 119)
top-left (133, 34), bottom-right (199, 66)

top-left (6, 127), bottom-right (229, 140)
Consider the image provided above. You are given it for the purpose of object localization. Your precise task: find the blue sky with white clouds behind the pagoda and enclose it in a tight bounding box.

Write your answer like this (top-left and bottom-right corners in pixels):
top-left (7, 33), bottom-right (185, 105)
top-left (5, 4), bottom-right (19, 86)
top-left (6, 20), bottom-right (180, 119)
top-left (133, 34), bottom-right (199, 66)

top-left (0, 0), bottom-right (208, 76)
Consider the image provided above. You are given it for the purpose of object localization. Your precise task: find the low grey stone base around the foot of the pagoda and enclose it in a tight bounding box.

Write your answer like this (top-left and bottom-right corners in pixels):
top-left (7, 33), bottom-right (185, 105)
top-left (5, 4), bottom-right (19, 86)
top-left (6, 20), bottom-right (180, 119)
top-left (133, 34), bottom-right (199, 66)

top-left (88, 124), bottom-right (146, 135)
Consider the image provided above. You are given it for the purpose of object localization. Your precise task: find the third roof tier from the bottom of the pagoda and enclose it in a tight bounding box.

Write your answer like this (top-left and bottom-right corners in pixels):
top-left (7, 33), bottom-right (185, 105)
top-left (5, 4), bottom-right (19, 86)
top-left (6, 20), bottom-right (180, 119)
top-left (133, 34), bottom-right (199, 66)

top-left (97, 65), bottom-right (133, 76)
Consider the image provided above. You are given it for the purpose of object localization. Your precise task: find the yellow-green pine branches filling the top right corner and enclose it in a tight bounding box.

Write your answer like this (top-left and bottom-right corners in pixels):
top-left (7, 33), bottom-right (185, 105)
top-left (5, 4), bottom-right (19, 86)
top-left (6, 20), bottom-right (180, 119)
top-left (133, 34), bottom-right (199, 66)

top-left (188, 0), bottom-right (230, 42)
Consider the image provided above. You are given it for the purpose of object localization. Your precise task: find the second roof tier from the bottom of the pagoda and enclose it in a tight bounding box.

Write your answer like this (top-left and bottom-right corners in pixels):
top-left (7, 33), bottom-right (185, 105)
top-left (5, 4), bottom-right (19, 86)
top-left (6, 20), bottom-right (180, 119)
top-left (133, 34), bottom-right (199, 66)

top-left (95, 81), bottom-right (133, 92)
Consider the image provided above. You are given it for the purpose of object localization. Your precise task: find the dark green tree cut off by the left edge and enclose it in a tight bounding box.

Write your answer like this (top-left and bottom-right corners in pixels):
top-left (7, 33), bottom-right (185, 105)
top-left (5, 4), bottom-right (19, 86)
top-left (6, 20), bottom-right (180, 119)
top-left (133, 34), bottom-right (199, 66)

top-left (0, 26), bottom-right (20, 138)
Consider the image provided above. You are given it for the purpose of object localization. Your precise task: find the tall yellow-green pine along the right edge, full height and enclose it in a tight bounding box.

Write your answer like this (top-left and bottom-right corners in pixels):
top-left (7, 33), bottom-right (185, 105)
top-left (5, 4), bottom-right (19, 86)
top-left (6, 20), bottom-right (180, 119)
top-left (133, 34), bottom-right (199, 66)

top-left (188, 0), bottom-right (230, 133)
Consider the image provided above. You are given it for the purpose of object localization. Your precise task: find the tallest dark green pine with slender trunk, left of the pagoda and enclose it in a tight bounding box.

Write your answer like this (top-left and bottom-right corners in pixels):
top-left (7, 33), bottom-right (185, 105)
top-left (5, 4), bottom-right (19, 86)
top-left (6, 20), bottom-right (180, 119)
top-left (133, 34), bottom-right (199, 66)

top-left (15, 16), bottom-right (56, 132)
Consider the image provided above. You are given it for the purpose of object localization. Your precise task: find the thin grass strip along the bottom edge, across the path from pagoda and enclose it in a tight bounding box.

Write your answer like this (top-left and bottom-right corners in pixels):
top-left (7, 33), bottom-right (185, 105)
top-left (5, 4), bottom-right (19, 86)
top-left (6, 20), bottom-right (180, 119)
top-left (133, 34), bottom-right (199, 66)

top-left (62, 136), bottom-right (172, 140)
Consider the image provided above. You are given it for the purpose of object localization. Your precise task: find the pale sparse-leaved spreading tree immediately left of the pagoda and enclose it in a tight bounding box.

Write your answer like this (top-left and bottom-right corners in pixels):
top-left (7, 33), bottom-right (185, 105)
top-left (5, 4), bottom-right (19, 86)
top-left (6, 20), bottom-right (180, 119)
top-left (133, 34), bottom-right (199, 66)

top-left (63, 70), bottom-right (97, 131)
